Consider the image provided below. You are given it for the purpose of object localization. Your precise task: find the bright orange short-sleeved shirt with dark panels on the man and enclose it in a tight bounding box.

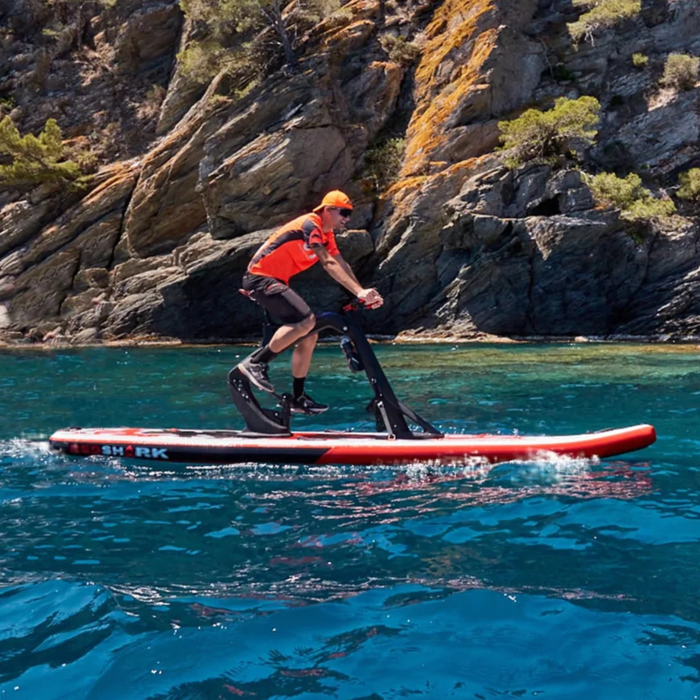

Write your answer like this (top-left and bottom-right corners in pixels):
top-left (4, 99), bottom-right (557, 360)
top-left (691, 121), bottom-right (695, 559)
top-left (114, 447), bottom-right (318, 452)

top-left (248, 213), bottom-right (340, 284)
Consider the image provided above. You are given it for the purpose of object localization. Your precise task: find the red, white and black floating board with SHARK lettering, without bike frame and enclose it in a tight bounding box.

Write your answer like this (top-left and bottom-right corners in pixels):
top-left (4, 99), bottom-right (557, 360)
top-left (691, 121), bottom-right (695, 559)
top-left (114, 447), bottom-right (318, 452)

top-left (49, 425), bottom-right (656, 465)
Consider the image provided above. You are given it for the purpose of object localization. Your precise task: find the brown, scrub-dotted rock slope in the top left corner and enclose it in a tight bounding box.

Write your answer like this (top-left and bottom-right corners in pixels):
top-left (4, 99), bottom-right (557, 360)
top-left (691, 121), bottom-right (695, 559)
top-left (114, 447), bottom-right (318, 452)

top-left (0, 0), bottom-right (183, 162)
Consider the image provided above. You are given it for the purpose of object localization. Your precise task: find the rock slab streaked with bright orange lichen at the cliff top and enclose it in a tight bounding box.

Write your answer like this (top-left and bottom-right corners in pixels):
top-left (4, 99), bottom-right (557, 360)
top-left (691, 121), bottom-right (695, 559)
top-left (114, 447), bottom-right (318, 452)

top-left (403, 0), bottom-right (545, 176)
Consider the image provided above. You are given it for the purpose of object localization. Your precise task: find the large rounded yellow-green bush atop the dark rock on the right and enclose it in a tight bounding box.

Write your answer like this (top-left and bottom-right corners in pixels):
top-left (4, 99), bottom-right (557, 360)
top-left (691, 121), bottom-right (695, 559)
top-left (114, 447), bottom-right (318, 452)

top-left (498, 97), bottom-right (600, 167)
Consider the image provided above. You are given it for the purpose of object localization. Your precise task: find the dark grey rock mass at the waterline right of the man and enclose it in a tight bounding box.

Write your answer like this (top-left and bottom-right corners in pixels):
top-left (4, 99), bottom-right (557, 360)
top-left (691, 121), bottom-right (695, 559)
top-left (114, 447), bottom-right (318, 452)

top-left (379, 159), bottom-right (700, 336)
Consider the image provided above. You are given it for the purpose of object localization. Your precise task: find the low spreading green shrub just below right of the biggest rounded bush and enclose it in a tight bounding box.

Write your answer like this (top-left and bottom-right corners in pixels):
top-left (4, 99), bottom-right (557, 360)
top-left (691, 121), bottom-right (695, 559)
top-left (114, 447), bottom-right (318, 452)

top-left (586, 173), bottom-right (676, 222)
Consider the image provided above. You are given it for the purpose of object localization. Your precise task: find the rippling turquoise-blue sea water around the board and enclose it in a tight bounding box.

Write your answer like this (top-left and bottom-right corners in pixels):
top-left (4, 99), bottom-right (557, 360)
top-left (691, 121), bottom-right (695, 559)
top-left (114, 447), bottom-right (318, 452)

top-left (0, 345), bottom-right (700, 700)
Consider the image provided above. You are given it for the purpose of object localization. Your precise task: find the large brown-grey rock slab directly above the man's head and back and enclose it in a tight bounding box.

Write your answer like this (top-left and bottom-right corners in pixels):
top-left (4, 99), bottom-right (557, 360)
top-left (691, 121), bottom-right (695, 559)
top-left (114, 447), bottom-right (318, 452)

top-left (201, 29), bottom-right (404, 238)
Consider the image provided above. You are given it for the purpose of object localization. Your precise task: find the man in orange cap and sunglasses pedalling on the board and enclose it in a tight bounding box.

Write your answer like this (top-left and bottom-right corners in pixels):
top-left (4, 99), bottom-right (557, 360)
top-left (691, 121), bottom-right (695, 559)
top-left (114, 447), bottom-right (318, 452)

top-left (238, 190), bottom-right (383, 413)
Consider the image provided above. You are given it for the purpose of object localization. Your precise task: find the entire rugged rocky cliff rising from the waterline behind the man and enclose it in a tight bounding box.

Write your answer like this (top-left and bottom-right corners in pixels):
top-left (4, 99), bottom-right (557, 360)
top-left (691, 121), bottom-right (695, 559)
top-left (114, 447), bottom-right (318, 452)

top-left (0, 0), bottom-right (700, 343)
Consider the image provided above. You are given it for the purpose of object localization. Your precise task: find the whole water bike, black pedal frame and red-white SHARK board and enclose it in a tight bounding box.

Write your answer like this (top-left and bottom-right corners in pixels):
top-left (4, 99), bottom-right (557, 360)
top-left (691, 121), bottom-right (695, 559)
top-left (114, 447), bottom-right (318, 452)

top-left (49, 304), bottom-right (656, 465)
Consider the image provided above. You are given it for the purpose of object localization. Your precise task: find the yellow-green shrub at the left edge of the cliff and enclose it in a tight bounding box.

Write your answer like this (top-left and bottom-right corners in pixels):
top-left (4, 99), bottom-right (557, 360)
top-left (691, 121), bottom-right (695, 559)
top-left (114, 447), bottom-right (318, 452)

top-left (0, 117), bottom-right (81, 185)
